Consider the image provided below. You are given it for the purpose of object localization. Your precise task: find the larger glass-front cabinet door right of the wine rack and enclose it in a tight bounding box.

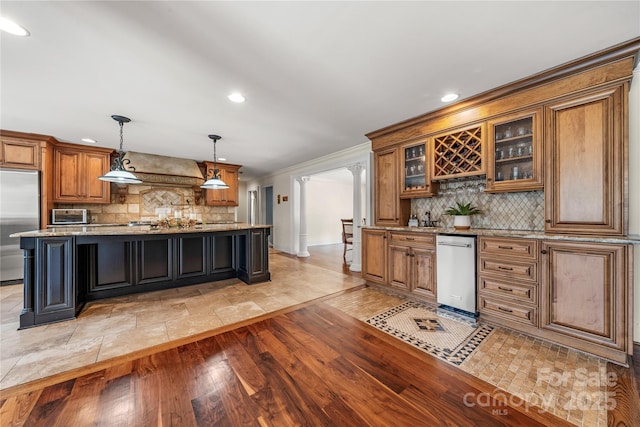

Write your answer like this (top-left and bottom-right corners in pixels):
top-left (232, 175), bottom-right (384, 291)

top-left (485, 109), bottom-right (543, 192)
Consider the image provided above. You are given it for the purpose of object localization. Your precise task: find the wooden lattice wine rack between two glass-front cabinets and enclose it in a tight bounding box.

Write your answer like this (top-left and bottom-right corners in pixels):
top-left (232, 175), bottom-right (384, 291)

top-left (433, 125), bottom-right (485, 180)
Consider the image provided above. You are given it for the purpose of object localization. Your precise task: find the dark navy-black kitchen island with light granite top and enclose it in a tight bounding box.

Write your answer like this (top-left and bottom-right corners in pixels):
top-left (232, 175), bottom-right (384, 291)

top-left (12, 223), bottom-right (271, 329)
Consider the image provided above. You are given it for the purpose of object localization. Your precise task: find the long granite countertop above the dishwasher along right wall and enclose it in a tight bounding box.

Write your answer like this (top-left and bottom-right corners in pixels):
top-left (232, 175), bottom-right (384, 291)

top-left (361, 225), bottom-right (640, 245)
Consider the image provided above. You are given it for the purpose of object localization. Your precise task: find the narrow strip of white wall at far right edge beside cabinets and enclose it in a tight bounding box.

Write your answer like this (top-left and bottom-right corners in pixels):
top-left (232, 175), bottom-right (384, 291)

top-left (629, 66), bottom-right (640, 343)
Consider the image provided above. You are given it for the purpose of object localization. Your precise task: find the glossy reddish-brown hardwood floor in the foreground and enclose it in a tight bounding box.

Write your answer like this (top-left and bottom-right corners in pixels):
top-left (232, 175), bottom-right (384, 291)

top-left (0, 303), bottom-right (570, 426)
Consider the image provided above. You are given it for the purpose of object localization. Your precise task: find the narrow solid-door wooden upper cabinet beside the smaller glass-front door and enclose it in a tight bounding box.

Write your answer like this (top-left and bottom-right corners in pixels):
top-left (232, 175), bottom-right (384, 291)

top-left (374, 148), bottom-right (411, 226)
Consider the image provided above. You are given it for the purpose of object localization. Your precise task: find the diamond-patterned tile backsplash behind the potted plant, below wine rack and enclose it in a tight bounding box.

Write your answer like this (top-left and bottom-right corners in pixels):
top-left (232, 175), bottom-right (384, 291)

top-left (411, 178), bottom-right (544, 231)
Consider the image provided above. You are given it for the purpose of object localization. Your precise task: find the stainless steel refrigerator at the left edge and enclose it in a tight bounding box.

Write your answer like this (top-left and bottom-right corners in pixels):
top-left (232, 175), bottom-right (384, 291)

top-left (0, 169), bottom-right (40, 284)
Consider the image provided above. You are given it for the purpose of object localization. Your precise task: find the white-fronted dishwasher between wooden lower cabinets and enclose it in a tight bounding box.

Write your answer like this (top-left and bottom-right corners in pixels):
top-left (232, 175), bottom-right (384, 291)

top-left (436, 235), bottom-right (476, 315)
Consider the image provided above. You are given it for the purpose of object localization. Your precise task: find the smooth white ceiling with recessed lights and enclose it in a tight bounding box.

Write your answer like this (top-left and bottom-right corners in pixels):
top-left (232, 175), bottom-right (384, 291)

top-left (0, 0), bottom-right (640, 179)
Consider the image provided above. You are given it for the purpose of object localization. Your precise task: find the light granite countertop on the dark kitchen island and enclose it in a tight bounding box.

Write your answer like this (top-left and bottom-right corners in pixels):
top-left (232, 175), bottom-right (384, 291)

top-left (10, 223), bottom-right (272, 237)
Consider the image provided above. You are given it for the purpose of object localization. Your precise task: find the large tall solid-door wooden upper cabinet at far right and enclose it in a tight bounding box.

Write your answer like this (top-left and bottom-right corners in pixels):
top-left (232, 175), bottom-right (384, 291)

top-left (545, 83), bottom-right (629, 235)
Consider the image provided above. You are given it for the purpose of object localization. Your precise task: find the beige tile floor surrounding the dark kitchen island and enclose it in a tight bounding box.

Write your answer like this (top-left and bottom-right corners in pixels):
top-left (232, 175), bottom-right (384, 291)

top-left (0, 249), bottom-right (364, 389)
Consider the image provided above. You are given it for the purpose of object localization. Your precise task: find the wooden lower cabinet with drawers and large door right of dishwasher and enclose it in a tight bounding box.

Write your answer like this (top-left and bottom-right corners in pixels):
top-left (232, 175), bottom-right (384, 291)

top-left (478, 237), bottom-right (633, 364)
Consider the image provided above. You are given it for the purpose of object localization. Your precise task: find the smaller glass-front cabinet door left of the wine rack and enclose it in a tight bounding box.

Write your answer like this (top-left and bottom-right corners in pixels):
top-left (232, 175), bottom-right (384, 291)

top-left (400, 139), bottom-right (434, 198)
